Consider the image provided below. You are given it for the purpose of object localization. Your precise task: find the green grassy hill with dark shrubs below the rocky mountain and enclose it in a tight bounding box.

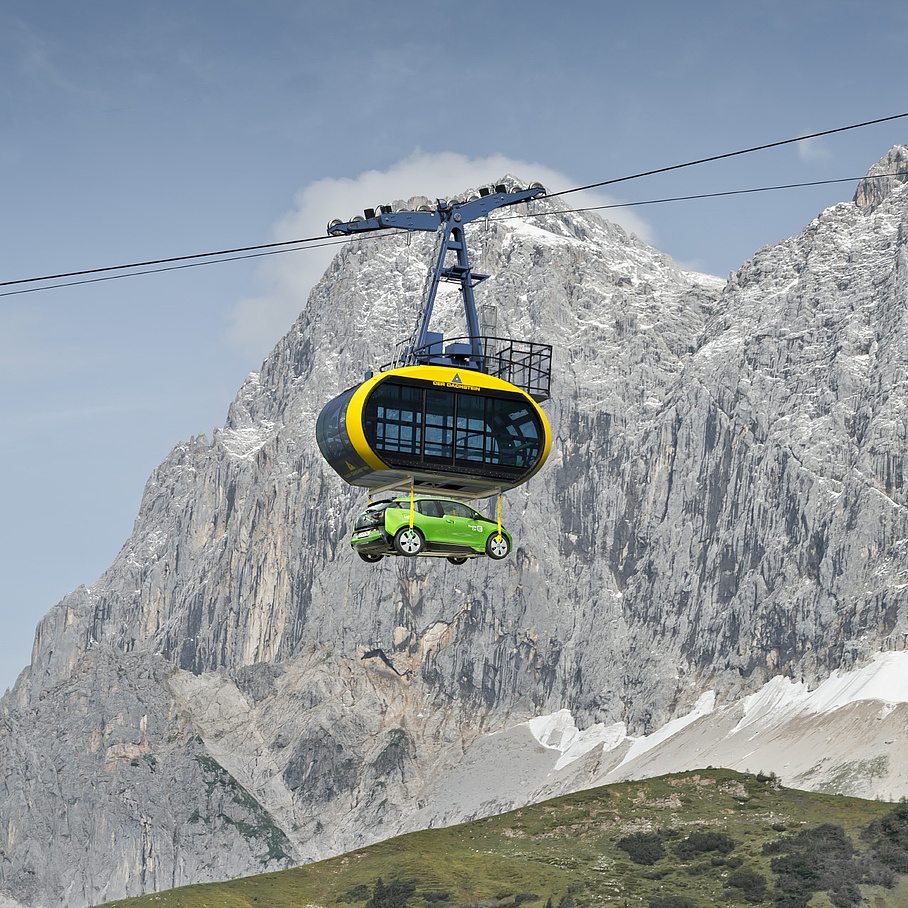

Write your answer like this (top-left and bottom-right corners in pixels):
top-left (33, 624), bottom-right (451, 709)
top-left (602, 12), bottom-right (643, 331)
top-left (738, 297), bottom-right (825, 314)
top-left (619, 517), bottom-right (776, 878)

top-left (94, 769), bottom-right (908, 908)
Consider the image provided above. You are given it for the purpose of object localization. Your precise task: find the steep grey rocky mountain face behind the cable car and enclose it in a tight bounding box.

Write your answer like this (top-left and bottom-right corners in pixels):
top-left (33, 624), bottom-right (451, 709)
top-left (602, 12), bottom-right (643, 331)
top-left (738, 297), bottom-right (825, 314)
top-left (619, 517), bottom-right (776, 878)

top-left (0, 146), bottom-right (908, 908)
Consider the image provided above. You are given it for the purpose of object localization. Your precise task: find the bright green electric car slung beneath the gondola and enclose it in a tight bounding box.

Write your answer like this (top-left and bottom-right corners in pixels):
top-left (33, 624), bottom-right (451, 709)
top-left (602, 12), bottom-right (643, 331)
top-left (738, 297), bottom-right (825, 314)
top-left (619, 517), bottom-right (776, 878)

top-left (350, 496), bottom-right (511, 564)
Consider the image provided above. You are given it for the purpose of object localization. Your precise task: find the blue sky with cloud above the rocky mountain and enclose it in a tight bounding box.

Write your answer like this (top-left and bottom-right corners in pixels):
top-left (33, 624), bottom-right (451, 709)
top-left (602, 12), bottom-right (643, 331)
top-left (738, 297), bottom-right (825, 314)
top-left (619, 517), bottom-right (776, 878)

top-left (0, 0), bottom-right (908, 692)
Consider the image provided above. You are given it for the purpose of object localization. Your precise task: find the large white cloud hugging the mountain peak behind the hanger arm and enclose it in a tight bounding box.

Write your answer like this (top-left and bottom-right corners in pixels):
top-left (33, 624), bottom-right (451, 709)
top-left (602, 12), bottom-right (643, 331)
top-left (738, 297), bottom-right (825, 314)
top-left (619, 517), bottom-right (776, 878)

top-left (229, 150), bottom-right (652, 356)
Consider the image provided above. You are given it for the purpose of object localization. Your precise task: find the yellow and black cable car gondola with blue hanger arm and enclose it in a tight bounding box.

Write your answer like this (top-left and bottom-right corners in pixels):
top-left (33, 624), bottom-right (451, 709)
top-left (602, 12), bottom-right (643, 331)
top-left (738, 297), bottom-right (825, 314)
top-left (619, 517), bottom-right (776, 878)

top-left (316, 184), bottom-right (552, 499)
